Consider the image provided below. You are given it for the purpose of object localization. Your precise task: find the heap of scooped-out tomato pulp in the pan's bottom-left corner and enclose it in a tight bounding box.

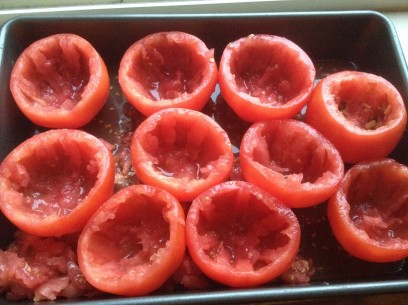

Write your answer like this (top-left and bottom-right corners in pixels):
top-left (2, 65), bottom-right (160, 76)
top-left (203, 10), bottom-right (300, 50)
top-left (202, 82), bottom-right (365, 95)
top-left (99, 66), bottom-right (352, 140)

top-left (0, 231), bottom-right (98, 301)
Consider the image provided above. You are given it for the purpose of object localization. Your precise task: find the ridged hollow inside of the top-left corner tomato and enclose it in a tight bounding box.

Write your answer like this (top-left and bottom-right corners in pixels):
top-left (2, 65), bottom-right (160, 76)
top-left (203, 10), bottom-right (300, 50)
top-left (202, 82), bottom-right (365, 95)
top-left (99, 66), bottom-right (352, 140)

top-left (20, 38), bottom-right (90, 110)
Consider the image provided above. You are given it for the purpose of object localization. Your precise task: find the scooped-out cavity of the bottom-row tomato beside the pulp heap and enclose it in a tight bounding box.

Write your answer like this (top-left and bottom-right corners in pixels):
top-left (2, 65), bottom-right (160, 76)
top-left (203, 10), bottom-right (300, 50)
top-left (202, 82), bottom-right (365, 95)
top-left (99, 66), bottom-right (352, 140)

top-left (87, 198), bottom-right (170, 278)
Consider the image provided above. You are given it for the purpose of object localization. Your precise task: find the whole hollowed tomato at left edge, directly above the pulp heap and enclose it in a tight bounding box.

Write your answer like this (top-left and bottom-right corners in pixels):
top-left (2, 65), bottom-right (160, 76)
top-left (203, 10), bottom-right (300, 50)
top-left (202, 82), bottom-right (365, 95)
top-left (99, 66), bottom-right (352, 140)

top-left (0, 129), bottom-right (115, 236)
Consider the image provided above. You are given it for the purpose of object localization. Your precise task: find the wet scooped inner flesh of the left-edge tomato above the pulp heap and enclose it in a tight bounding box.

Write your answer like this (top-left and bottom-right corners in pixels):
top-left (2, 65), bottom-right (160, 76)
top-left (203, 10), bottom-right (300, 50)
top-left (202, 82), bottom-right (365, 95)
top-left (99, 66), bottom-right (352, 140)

top-left (19, 148), bottom-right (98, 217)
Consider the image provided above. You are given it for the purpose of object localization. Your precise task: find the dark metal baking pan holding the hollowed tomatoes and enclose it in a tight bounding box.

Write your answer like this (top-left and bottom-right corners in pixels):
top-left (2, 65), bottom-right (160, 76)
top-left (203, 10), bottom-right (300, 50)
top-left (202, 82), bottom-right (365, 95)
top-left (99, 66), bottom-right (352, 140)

top-left (0, 11), bottom-right (408, 305)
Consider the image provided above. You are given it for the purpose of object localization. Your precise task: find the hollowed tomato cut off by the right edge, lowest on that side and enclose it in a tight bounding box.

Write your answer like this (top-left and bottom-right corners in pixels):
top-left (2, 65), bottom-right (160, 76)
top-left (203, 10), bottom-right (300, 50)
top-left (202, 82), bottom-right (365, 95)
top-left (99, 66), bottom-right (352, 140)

top-left (328, 159), bottom-right (408, 262)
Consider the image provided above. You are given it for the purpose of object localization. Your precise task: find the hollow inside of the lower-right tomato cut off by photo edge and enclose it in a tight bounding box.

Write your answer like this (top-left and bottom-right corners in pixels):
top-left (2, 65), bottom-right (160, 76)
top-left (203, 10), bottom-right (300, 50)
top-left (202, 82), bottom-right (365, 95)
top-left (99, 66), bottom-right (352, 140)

top-left (347, 160), bottom-right (408, 244)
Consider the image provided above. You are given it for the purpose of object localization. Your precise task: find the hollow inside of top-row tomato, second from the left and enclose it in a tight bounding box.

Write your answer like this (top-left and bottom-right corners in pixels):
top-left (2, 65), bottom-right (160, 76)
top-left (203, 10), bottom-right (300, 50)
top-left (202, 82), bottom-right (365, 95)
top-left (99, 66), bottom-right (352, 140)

top-left (129, 35), bottom-right (207, 101)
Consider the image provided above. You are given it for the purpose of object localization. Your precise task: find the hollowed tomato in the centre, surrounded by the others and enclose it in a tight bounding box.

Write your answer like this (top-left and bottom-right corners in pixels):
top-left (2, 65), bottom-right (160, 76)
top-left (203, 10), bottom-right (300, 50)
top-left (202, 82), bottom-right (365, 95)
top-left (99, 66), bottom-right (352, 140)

top-left (130, 108), bottom-right (233, 202)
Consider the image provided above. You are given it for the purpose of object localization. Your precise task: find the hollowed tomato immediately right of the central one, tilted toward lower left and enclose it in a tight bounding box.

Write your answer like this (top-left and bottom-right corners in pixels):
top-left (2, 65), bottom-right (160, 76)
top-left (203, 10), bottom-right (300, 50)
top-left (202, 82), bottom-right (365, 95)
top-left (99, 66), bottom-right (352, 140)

top-left (240, 120), bottom-right (344, 208)
